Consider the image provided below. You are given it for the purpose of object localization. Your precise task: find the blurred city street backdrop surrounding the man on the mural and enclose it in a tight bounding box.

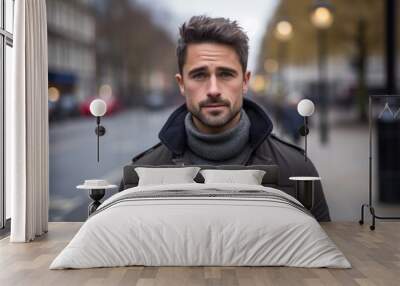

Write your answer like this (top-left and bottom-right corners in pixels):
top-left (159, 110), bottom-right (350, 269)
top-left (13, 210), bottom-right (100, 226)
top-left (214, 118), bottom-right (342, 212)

top-left (37, 0), bottom-right (400, 221)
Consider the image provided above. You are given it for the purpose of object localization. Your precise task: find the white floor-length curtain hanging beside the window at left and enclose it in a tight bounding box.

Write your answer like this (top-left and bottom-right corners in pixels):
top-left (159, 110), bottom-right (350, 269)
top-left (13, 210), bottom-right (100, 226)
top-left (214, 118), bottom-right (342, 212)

top-left (6, 0), bottom-right (49, 242)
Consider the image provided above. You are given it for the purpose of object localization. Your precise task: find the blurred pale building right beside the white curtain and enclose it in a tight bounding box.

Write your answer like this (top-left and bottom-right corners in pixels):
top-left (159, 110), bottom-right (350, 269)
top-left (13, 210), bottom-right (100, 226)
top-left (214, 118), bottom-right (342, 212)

top-left (47, 0), bottom-right (96, 118)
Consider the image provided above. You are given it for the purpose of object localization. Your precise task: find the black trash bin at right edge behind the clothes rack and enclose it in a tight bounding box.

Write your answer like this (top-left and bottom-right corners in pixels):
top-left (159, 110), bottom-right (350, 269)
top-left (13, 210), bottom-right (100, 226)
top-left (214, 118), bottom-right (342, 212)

top-left (376, 118), bottom-right (400, 203)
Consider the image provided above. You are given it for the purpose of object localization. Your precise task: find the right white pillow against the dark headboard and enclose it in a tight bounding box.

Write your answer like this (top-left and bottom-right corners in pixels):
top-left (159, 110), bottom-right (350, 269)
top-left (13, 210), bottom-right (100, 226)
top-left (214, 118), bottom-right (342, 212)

top-left (200, 169), bottom-right (265, 185)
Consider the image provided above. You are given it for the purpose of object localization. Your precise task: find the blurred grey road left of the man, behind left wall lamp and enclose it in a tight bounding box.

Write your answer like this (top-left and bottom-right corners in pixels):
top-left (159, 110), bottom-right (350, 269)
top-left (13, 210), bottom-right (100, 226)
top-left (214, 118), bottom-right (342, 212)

top-left (49, 109), bottom-right (172, 221)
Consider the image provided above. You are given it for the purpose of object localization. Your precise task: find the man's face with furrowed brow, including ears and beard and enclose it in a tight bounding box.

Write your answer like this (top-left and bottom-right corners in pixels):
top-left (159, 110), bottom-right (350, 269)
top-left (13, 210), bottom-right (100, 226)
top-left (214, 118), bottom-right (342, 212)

top-left (176, 43), bottom-right (250, 133)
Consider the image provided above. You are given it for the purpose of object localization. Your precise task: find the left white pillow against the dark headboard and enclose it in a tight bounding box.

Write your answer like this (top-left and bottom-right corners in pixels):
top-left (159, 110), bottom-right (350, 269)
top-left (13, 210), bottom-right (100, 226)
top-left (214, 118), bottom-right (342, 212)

top-left (135, 167), bottom-right (200, 186)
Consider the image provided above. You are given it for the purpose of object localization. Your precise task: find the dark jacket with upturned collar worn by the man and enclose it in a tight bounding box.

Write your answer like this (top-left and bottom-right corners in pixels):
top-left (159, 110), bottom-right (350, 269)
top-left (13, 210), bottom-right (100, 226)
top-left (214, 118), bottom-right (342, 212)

top-left (119, 98), bottom-right (330, 221)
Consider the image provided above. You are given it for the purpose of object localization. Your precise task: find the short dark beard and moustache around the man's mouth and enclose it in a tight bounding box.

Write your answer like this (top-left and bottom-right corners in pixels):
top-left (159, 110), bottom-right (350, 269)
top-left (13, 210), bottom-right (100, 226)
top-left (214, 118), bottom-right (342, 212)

top-left (187, 98), bottom-right (242, 128)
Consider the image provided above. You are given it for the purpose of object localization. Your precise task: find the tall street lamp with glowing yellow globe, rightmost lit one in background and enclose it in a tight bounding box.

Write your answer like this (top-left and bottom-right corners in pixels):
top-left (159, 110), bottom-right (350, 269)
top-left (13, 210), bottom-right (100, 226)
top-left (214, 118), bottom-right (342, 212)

top-left (310, 0), bottom-right (333, 144)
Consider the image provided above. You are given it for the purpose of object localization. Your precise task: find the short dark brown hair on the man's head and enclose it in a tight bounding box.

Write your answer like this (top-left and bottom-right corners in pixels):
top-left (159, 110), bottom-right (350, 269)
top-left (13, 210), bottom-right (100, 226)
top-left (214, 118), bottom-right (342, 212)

top-left (176, 16), bottom-right (249, 74)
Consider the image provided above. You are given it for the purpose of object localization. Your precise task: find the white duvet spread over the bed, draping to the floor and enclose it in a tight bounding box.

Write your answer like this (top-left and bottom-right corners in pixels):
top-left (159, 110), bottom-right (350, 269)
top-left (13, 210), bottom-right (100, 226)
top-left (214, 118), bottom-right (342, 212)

top-left (50, 183), bottom-right (351, 269)
